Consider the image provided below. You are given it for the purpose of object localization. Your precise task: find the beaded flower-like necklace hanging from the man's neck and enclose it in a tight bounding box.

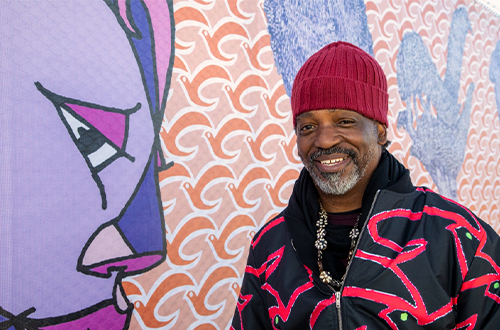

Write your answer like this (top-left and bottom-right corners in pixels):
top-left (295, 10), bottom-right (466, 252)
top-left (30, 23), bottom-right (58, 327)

top-left (314, 202), bottom-right (361, 289)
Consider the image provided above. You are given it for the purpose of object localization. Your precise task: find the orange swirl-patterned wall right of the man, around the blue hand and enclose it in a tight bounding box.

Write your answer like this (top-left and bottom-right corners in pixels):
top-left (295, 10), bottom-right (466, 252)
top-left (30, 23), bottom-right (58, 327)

top-left (367, 1), bottom-right (500, 232)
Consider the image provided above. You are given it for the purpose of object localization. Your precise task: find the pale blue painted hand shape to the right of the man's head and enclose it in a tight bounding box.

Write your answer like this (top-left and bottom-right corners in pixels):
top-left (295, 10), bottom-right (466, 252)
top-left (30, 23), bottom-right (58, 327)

top-left (397, 7), bottom-right (474, 199)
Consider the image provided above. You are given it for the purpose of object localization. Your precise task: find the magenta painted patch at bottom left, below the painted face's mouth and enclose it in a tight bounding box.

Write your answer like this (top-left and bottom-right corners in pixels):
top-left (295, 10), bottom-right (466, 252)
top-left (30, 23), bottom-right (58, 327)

top-left (40, 305), bottom-right (128, 330)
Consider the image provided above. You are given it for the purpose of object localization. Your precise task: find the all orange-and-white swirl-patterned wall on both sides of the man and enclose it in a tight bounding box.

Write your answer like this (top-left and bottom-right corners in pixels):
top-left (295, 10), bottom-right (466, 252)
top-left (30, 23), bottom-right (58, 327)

top-left (124, 0), bottom-right (500, 329)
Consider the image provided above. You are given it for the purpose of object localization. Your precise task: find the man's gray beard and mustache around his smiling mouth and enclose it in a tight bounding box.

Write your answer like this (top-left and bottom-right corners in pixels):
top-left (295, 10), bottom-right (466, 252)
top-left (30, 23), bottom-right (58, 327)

top-left (304, 147), bottom-right (376, 196)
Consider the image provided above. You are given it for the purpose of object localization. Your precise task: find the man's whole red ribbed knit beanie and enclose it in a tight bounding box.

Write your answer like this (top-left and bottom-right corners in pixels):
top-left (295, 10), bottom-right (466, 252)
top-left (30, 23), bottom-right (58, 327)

top-left (291, 41), bottom-right (389, 126)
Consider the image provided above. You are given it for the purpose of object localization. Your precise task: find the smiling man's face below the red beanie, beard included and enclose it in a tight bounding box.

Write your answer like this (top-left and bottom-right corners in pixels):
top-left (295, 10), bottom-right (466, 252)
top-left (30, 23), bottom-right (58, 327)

top-left (296, 110), bottom-right (387, 195)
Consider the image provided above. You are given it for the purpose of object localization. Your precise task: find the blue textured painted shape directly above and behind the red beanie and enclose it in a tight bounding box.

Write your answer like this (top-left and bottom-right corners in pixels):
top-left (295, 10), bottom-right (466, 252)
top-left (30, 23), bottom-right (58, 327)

top-left (264, 0), bottom-right (373, 96)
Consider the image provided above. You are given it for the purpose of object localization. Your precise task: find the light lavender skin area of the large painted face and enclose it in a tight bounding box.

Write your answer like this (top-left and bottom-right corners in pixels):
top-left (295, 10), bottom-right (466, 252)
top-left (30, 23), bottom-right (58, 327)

top-left (0, 0), bottom-right (156, 320)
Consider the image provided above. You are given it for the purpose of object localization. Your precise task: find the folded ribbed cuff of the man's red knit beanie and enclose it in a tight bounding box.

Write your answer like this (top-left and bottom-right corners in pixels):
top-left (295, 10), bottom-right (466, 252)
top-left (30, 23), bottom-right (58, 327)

top-left (291, 76), bottom-right (389, 126)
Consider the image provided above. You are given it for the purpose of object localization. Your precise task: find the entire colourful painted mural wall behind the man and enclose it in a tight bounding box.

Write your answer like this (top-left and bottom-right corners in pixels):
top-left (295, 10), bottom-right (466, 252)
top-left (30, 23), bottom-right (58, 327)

top-left (0, 0), bottom-right (500, 329)
